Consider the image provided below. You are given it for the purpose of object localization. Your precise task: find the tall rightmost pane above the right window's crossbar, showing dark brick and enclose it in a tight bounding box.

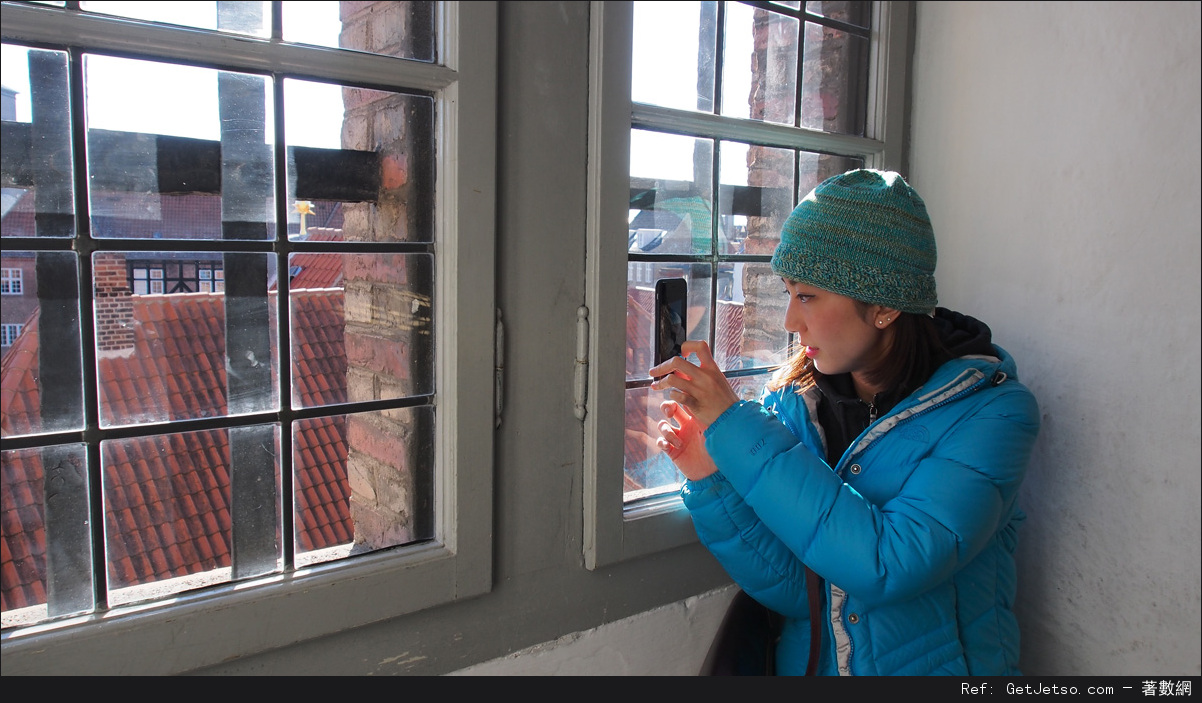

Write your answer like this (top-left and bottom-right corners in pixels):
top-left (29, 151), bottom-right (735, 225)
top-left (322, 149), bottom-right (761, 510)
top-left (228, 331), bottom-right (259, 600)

top-left (802, 22), bottom-right (868, 136)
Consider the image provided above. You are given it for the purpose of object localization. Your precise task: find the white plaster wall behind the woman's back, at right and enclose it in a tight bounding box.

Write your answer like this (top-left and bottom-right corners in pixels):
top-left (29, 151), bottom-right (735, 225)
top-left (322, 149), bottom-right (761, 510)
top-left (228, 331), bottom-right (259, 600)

top-left (910, 2), bottom-right (1202, 675)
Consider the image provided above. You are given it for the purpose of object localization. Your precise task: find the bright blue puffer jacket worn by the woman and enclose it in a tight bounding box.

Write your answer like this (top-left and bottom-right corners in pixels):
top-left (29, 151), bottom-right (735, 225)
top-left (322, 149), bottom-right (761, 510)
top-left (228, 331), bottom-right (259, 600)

top-left (682, 347), bottom-right (1039, 677)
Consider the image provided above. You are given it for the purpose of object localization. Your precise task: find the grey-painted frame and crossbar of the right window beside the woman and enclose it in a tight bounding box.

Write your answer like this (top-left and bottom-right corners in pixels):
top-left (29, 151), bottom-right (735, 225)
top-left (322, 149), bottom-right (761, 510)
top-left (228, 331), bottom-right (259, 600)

top-left (584, 1), bottom-right (914, 568)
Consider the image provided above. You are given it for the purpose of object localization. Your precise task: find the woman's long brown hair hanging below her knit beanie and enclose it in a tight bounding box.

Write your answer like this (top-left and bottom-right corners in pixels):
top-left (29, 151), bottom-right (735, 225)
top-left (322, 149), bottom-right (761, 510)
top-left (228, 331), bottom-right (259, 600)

top-left (768, 310), bottom-right (950, 393)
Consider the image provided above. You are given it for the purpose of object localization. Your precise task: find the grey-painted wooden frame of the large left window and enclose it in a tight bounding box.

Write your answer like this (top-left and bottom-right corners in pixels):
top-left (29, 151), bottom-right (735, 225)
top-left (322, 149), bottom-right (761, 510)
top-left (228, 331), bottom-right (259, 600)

top-left (0, 2), bottom-right (498, 674)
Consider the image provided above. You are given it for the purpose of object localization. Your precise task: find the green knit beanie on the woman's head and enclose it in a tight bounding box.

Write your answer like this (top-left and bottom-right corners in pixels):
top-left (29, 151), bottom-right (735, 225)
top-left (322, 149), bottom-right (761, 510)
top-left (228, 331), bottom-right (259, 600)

top-left (772, 168), bottom-right (939, 314)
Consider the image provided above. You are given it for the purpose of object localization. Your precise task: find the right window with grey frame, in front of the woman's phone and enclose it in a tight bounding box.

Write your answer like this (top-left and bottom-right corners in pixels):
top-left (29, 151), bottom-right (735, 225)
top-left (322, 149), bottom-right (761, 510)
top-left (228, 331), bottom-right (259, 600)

top-left (585, 1), bottom-right (910, 567)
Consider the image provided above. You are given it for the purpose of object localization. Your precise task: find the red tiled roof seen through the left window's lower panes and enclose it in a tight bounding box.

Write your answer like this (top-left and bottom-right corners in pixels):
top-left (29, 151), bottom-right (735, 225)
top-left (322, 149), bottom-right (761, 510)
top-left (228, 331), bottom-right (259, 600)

top-left (0, 290), bottom-right (355, 612)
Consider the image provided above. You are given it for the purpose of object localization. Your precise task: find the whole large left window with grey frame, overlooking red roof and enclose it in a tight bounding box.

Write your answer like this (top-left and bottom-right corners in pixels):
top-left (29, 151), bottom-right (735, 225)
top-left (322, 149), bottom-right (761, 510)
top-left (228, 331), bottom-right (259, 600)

top-left (0, 1), bottom-right (495, 671)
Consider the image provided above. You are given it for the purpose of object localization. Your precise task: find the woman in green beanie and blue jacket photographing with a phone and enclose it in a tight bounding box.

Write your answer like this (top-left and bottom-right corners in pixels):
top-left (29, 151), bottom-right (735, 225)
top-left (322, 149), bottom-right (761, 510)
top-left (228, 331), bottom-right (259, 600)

top-left (650, 169), bottom-right (1039, 675)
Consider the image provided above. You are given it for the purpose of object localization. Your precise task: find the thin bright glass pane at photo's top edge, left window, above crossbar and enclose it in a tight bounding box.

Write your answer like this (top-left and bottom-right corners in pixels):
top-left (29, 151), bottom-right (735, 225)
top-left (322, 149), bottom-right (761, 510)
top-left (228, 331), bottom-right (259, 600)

top-left (79, 0), bottom-right (272, 37)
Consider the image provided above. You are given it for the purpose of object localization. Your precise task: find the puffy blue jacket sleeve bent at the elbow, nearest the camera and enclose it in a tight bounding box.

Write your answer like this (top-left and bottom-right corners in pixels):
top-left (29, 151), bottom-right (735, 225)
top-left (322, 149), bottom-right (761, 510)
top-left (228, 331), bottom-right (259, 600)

top-left (706, 382), bottom-right (1039, 604)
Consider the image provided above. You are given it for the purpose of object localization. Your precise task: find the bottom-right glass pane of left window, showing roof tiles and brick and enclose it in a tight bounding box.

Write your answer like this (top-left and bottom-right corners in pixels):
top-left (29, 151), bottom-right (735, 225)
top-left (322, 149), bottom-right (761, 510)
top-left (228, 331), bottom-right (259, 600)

top-left (292, 406), bottom-right (435, 566)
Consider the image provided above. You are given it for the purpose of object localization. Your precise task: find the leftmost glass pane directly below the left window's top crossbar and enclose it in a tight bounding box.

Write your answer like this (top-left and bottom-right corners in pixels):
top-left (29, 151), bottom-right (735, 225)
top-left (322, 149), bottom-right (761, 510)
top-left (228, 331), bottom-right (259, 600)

top-left (0, 44), bottom-right (75, 241)
